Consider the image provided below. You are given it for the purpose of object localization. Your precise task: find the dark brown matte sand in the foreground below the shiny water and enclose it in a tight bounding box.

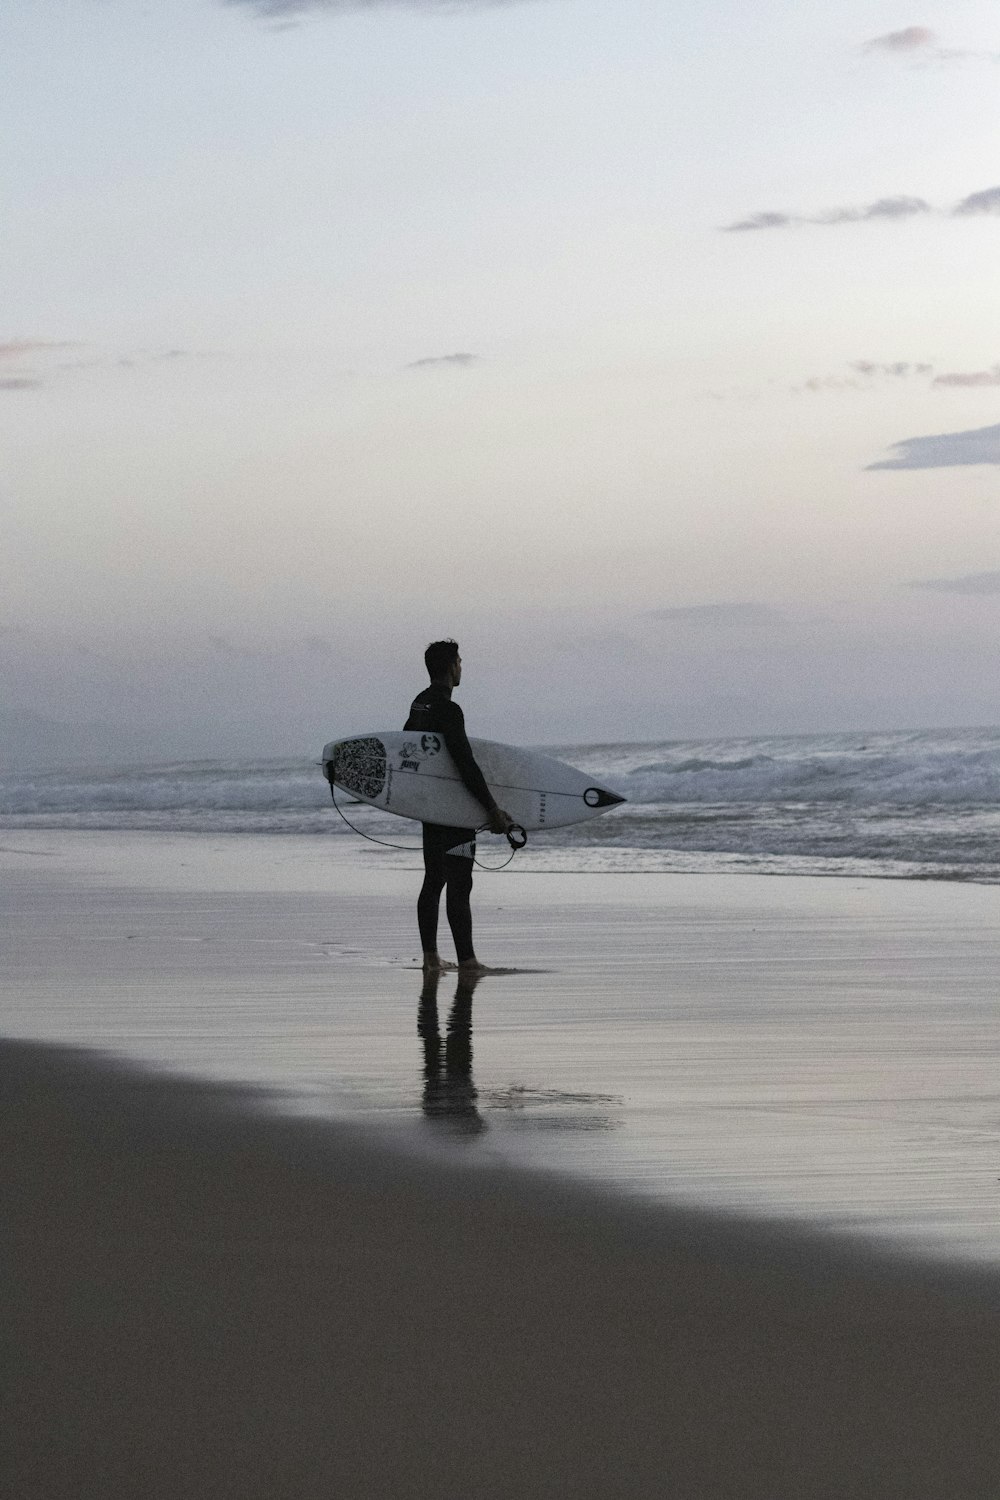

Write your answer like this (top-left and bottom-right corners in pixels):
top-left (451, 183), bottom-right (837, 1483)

top-left (0, 1043), bottom-right (1000, 1500)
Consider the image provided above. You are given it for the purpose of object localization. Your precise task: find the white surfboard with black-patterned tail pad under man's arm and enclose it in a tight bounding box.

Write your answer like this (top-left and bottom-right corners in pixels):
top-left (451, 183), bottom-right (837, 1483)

top-left (322, 729), bottom-right (625, 831)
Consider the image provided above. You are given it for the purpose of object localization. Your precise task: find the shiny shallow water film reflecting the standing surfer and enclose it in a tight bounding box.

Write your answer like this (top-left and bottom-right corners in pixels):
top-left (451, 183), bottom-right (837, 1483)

top-left (0, 833), bottom-right (1000, 1260)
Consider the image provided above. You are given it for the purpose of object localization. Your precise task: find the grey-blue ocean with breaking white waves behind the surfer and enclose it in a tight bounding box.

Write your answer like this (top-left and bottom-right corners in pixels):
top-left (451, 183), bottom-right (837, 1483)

top-left (0, 729), bottom-right (1000, 884)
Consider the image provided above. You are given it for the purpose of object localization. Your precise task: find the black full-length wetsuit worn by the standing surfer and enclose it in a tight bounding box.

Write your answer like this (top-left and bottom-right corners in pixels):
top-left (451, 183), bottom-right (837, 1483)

top-left (403, 683), bottom-right (496, 963)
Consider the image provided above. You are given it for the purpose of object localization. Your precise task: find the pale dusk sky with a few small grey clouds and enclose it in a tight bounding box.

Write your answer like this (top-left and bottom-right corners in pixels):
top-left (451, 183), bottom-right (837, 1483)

top-left (0, 0), bottom-right (1000, 759)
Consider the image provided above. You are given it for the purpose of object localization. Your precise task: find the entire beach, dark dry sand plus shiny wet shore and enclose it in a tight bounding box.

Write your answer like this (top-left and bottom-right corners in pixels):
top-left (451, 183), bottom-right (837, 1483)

top-left (0, 833), bottom-right (1000, 1500)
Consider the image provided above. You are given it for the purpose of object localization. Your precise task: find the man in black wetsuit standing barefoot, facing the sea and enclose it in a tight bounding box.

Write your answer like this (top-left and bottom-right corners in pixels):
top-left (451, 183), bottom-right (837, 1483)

top-left (403, 641), bottom-right (513, 974)
